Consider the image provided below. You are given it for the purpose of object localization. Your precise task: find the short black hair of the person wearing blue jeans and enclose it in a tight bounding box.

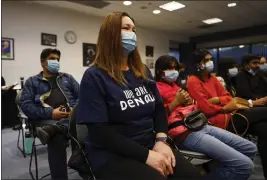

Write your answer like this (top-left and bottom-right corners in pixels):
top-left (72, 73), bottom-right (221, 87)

top-left (155, 55), bottom-right (178, 81)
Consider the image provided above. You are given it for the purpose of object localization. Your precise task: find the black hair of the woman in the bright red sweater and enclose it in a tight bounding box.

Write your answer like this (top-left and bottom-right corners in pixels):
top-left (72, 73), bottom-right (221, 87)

top-left (191, 49), bottom-right (211, 81)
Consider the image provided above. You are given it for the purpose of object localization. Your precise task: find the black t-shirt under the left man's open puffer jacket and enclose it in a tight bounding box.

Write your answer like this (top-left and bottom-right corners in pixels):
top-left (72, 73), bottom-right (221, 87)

top-left (45, 76), bottom-right (67, 109)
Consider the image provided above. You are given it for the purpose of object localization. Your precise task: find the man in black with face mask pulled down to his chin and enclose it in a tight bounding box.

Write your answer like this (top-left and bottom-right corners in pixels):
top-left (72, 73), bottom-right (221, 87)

top-left (236, 54), bottom-right (267, 105)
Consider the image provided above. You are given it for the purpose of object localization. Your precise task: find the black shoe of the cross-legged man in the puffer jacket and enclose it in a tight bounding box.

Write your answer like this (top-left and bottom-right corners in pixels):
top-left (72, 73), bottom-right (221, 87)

top-left (36, 125), bottom-right (67, 145)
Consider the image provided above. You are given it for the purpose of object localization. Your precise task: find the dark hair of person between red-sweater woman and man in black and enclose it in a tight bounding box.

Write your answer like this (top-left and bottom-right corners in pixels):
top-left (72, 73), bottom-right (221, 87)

top-left (217, 57), bottom-right (238, 92)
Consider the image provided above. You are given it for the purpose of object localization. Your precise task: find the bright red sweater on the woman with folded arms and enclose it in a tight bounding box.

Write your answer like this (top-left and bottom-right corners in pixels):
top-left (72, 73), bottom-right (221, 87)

top-left (187, 76), bottom-right (232, 129)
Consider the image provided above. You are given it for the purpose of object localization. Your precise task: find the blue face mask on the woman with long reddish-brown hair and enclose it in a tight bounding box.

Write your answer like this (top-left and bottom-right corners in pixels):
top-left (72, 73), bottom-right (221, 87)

top-left (121, 31), bottom-right (136, 56)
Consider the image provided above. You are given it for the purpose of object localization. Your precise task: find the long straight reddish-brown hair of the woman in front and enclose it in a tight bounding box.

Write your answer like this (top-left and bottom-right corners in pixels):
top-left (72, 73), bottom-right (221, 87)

top-left (93, 12), bottom-right (147, 85)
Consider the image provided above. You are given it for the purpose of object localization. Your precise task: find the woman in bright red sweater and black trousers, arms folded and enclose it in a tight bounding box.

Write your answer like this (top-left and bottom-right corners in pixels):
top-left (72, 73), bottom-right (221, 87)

top-left (187, 49), bottom-right (267, 178)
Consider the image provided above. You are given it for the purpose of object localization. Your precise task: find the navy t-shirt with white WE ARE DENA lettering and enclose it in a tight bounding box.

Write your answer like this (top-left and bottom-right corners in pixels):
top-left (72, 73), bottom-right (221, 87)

top-left (77, 66), bottom-right (162, 168)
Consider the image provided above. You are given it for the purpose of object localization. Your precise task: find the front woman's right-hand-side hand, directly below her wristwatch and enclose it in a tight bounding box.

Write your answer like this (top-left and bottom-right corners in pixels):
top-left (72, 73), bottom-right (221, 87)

top-left (153, 141), bottom-right (176, 175)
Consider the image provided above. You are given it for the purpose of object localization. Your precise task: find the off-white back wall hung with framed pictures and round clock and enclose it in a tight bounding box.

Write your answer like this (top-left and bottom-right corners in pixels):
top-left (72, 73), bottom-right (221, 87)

top-left (2, 1), bottom-right (185, 84)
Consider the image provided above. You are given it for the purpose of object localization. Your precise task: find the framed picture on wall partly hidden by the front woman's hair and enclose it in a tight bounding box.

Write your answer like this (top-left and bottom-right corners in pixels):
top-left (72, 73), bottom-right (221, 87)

top-left (83, 43), bottom-right (96, 67)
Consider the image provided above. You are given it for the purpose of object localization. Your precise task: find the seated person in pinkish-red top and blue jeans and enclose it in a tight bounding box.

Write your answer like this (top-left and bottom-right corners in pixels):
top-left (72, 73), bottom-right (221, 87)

top-left (155, 56), bottom-right (257, 180)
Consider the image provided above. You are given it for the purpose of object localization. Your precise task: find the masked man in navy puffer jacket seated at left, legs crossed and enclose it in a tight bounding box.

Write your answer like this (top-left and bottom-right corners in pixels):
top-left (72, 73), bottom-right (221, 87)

top-left (20, 49), bottom-right (79, 179)
